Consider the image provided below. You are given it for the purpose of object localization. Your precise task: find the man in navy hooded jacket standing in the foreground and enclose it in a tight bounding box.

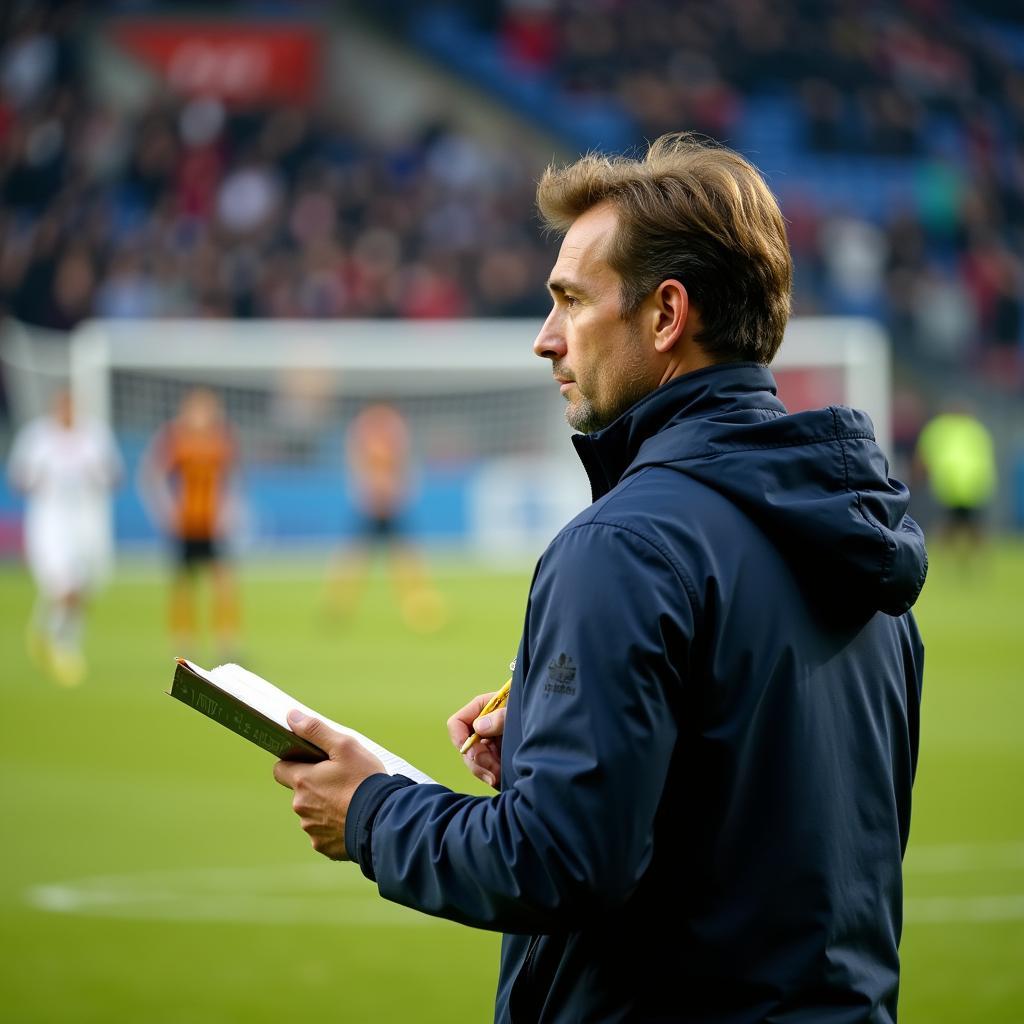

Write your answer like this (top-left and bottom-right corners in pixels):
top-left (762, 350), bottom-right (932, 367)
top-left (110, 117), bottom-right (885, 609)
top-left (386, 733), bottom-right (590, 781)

top-left (275, 135), bottom-right (926, 1024)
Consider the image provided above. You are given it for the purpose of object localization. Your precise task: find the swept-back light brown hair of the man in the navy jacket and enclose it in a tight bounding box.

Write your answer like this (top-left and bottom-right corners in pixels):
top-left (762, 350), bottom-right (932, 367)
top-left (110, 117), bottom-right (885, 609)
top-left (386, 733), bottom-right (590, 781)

top-left (537, 132), bottom-right (793, 365)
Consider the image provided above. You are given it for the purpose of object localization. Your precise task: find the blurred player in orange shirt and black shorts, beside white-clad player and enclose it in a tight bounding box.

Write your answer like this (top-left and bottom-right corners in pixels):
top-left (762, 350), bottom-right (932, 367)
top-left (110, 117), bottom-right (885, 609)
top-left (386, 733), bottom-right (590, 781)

top-left (140, 388), bottom-right (240, 658)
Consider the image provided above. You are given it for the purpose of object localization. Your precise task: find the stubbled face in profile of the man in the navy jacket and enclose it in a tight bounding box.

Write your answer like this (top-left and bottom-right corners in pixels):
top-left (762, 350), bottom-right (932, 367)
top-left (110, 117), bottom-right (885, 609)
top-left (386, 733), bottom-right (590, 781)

top-left (534, 203), bottom-right (657, 433)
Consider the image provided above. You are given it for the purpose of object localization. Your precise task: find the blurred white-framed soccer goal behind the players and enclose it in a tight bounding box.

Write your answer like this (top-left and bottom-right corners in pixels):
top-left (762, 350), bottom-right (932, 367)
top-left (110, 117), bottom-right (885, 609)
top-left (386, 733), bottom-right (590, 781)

top-left (71, 319), bottom-right (889, 557)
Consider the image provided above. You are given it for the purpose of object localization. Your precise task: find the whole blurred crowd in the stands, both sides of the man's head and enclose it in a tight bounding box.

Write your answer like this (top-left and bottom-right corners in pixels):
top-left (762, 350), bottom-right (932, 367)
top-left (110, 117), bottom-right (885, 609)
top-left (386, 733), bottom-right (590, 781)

top-left (0, 0), bottom-right (1024, 386)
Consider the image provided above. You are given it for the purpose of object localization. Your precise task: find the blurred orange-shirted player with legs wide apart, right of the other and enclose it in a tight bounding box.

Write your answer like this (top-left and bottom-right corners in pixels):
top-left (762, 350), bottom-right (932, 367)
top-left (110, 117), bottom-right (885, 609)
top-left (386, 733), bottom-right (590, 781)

top-left (329, 403), bottom-right (444, 632)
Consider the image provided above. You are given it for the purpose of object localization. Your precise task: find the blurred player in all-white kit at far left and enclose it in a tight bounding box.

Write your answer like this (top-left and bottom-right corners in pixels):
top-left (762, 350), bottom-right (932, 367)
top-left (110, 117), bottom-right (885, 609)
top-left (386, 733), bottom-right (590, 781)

top-left (8, 390), bottom-right (123, 686)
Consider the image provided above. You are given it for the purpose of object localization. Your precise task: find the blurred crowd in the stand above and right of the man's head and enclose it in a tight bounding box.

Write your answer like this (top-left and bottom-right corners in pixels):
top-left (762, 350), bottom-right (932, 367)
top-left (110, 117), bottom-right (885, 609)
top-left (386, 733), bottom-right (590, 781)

top-left (483, 0), bottom-right (1024, 385)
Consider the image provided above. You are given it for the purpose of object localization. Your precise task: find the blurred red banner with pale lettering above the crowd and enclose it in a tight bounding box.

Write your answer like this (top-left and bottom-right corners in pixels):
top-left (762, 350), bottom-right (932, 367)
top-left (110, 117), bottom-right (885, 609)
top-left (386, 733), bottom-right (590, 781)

top-left (107, 19), bottom-right (319, 104)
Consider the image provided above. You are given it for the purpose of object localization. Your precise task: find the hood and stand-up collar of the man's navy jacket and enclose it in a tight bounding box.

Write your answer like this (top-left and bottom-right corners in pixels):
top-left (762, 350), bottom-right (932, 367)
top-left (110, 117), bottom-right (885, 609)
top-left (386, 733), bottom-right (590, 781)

top-left (572, 362), bottom-right (928, 615)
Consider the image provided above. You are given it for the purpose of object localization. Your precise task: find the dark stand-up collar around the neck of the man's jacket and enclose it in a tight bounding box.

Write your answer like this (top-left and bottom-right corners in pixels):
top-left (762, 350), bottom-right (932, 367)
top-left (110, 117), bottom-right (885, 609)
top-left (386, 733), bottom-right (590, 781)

top-left (572, 362), bottom-right (785, 501)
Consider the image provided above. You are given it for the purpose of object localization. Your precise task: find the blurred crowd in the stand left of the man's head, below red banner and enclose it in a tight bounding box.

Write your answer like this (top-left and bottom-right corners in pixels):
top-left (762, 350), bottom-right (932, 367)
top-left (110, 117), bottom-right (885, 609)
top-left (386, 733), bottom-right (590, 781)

top-left (0, 1), bottom-right (547, 329)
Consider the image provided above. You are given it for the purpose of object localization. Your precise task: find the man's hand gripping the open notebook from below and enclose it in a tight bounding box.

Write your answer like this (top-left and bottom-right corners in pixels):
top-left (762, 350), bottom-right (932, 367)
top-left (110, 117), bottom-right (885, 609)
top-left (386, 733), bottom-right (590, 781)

top-left (273, 711), bottom-right (385, 860)
